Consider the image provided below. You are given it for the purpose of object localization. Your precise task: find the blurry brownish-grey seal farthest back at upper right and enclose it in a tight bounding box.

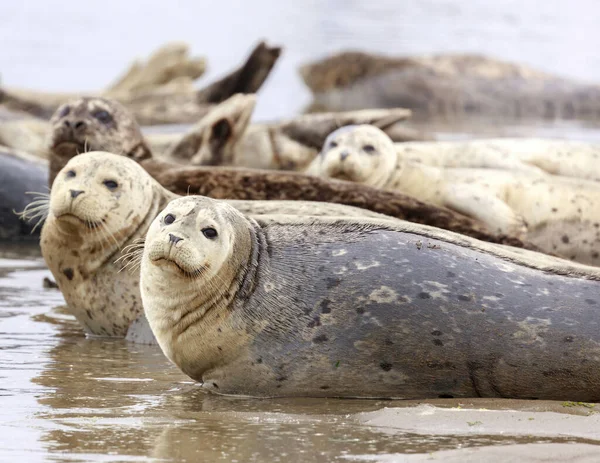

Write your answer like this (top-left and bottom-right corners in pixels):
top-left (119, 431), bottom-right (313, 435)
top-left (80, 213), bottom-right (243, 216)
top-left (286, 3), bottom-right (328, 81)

top-left (299, 52), bottom-right (600, 119)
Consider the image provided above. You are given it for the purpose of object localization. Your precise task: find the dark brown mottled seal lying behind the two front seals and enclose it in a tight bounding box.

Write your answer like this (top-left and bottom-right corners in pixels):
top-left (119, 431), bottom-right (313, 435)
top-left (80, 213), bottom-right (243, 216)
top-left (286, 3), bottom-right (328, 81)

top-left (41, 95), bottom-right (524, 246)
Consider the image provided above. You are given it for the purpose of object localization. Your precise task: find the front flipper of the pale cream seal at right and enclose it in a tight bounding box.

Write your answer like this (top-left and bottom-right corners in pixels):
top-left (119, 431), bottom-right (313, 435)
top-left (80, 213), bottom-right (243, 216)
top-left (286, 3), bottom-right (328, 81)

top-left (444, 184), bottom-right (527, 237)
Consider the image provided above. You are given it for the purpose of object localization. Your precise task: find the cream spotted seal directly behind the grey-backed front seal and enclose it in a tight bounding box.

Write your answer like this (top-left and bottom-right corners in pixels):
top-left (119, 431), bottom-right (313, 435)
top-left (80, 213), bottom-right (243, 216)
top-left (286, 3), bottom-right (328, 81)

top-left (38, 152), bottom-right (392, 342)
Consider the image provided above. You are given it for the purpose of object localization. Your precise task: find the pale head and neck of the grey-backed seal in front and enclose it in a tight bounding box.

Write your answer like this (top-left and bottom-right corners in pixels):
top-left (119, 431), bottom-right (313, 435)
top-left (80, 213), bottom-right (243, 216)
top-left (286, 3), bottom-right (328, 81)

top-left (140, 196), bottom-right (258, 379)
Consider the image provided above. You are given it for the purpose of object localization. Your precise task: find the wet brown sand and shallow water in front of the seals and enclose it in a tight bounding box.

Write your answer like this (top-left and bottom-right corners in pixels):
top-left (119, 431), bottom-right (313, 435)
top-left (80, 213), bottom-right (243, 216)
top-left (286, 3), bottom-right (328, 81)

top-left (0, 246), bottom-right (600, 462)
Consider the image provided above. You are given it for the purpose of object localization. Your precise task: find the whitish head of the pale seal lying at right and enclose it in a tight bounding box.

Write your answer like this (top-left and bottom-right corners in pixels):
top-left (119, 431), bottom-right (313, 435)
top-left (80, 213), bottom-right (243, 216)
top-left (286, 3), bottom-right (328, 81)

top-left (307, 124), bottom-right (397, 188)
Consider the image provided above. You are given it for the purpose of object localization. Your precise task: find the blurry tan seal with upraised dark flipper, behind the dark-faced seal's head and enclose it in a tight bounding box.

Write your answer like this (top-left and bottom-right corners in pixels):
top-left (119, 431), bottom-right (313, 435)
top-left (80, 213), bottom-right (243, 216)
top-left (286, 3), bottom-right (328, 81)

top-left (0, 42), bottom-right (281, 125)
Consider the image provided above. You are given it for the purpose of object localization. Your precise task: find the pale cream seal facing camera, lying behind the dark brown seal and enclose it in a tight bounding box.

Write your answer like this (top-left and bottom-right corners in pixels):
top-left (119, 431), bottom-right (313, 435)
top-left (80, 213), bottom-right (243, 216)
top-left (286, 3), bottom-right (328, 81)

top-left (307, 125), bottom-right (600, 265)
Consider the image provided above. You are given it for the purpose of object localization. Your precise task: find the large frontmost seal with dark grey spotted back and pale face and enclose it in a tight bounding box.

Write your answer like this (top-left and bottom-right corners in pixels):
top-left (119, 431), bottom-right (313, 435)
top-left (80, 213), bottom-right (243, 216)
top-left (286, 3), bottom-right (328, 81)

top-left (140, 196), bottom-right (600, 401)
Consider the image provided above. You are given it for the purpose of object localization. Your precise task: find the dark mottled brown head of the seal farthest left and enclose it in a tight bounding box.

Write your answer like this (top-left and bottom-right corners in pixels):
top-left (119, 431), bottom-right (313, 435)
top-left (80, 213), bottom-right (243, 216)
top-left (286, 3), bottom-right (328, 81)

top-left (47, 98), bottom-right (152, 185)
